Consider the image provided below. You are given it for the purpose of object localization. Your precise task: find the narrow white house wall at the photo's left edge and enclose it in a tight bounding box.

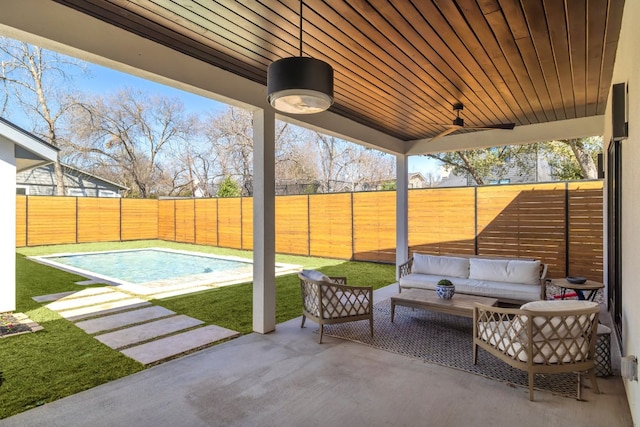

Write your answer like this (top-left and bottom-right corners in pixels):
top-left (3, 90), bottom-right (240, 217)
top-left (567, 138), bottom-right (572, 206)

top-left (0, 136), bottom-right (16, 313)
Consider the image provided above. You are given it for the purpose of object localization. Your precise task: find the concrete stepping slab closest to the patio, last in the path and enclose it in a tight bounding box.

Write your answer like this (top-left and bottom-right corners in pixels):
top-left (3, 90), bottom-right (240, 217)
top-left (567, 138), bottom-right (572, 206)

top-left (121, 325), bottom-right (240, 365)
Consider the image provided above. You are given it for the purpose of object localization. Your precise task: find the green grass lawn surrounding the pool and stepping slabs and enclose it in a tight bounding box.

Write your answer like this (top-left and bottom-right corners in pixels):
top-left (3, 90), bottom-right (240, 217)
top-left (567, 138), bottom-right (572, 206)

top-left (0, 240), bottom-right (395, 419)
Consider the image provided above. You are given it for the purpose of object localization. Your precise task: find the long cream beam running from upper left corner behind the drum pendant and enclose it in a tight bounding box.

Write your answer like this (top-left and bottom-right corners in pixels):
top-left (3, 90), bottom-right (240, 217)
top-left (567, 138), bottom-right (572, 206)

top-left (0, 0), bottom-right (400, 154)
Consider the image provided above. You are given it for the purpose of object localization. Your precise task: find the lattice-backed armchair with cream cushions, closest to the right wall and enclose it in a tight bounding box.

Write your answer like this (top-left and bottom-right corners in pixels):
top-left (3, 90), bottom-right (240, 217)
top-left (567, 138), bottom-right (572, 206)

top-left (473, 300), bottom-right (600, 400)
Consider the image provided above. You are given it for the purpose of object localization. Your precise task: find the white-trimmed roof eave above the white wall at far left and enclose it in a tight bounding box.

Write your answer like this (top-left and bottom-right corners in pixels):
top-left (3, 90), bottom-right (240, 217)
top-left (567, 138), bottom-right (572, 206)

top-left (0, 117), bottom-right (60, 172)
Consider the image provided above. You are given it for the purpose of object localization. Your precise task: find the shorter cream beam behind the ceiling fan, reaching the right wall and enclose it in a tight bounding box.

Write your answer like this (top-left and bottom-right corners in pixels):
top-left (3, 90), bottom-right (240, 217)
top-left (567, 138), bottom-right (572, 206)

top-left (407, 116), bottom-right (604, 155)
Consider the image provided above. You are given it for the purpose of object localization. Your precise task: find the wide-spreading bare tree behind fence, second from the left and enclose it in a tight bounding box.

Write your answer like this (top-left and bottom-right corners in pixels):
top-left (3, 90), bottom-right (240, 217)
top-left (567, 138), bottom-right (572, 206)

top-left (68, 89), bottom-right (196, 198)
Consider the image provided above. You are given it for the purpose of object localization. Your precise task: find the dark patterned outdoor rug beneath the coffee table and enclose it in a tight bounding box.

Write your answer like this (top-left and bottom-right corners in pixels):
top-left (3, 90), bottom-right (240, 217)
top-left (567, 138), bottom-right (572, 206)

top-left (324, 300), bottom-right (589, 398)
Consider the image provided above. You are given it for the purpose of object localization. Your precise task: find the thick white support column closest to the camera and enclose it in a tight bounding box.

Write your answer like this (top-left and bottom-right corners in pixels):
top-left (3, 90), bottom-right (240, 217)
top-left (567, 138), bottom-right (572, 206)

top-left (253, 110), bottom-right (276, 334)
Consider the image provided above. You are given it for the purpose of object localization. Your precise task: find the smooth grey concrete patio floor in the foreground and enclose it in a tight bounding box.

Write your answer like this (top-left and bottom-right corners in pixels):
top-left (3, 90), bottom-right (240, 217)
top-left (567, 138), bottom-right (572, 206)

top-left (0, 286), bottom-right (633, 427)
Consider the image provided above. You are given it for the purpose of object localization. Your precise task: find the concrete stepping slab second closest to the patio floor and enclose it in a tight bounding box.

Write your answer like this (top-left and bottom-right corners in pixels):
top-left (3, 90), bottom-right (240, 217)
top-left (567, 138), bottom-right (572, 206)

top-left (95, 315), bottom-right (203, 349)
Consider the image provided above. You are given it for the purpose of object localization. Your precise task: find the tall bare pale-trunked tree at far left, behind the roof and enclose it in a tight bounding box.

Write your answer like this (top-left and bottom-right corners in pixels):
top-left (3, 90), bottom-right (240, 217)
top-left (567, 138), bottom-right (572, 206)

top-left (0, 37), bottom-right (85, 195)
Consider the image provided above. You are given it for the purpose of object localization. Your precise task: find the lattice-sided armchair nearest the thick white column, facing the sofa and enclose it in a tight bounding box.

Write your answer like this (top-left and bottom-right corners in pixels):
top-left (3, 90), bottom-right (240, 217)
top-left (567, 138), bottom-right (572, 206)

top-left (298, 273), bottom-right (373, 343)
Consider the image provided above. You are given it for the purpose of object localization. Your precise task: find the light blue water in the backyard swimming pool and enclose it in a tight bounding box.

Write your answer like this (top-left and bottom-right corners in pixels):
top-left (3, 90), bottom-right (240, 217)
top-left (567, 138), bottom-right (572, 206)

top-left (43, 249), bottom-right (251, 284)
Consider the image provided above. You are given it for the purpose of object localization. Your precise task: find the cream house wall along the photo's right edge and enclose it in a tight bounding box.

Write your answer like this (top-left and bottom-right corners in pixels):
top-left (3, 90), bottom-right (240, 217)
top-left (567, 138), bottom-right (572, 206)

top-left (604, 0), bottom-right (640, 424)
